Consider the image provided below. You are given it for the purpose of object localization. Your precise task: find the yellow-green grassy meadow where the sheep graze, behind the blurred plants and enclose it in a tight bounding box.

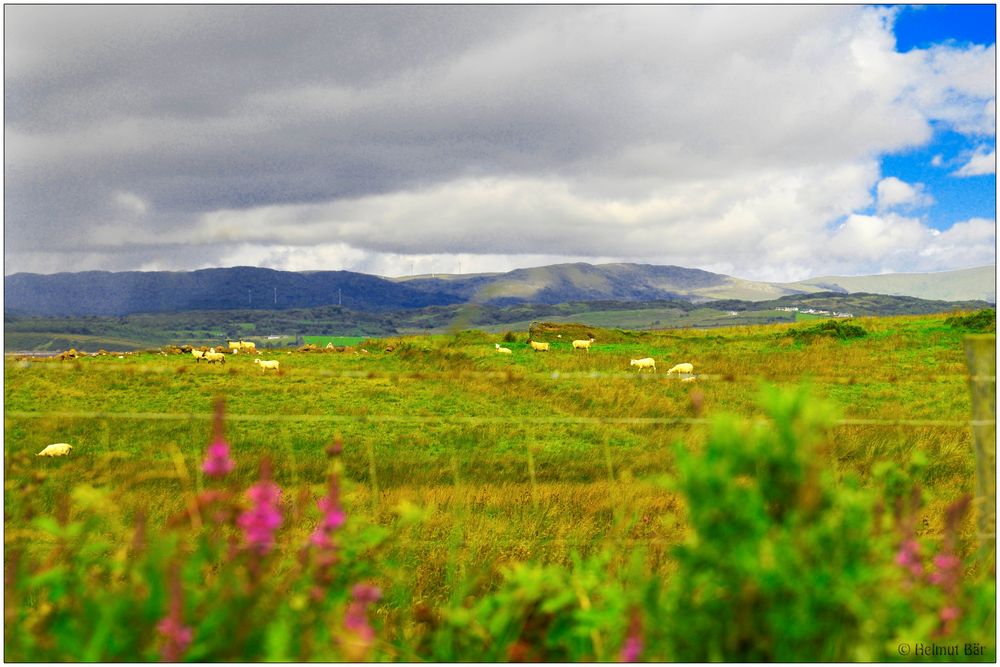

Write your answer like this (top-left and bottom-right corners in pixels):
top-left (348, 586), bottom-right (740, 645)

top-left (4, 315), bottom-right (995, 660)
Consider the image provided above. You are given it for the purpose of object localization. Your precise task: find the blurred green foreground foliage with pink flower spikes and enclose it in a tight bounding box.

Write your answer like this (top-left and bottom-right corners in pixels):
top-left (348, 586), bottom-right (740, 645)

top-left (4, 390), bottom-right (996, 662)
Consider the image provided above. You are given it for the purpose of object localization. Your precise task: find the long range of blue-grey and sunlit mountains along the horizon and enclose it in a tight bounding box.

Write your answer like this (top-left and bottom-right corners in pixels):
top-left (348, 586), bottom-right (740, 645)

top-left (4, 263), bottom-right (996, 316)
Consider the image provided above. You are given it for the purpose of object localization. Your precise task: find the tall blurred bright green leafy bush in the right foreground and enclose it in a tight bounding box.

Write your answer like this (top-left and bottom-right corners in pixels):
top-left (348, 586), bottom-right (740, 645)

top-left (666, 390), bottom-right (995, 662)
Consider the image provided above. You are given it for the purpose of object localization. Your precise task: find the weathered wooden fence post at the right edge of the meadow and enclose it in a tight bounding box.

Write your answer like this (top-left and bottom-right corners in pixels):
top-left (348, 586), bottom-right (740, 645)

top-left (963, 334), bottom-right (997, 562)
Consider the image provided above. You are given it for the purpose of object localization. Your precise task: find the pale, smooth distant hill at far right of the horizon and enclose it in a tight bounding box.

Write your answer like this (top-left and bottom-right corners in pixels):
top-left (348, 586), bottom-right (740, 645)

top-left (788, 266), bottom-right (997, 303)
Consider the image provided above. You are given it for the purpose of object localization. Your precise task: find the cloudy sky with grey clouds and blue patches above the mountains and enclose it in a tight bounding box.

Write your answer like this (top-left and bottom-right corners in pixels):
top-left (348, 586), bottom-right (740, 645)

top-left (4, 5), bottom-right (996, 280)
